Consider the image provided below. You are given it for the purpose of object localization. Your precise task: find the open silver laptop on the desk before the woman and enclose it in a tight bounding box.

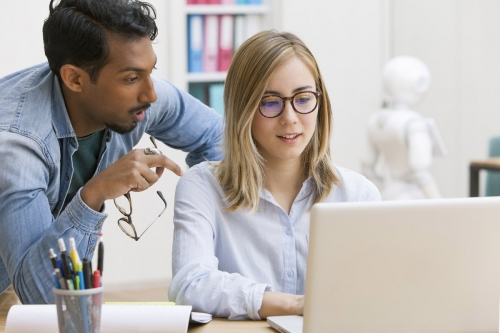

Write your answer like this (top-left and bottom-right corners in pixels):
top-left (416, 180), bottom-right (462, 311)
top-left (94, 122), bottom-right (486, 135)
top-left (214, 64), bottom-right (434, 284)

top-left (268, 197), bottom-right (500, 333)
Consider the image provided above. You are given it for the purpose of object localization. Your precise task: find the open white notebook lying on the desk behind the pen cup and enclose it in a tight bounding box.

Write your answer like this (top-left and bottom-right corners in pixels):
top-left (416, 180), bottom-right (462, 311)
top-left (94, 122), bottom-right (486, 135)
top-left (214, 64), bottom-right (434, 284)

top-left (5, 303), bottom-right (212, 333)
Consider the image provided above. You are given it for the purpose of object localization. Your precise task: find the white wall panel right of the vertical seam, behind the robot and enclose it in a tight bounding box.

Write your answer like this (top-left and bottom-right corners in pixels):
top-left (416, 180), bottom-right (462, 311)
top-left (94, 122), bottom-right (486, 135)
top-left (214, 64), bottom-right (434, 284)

top-left (392, 0), bottom-right (500, 197)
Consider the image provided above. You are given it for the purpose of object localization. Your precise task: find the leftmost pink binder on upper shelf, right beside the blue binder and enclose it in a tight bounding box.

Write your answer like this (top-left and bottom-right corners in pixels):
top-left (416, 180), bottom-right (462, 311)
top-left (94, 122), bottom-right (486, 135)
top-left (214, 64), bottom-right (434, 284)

top-left (203, 15), bottom-right (219, 72)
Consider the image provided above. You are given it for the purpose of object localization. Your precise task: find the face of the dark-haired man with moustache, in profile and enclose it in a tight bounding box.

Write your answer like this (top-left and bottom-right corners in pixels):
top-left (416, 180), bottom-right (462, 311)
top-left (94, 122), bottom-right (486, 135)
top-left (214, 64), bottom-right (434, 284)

top-left (80, 35), bottom-right (157, 134)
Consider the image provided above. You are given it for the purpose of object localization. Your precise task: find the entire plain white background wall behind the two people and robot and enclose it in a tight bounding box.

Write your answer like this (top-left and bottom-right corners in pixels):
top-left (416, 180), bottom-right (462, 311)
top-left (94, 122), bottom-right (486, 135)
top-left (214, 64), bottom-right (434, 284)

top-left (0, 0), bottom-right (500, 287)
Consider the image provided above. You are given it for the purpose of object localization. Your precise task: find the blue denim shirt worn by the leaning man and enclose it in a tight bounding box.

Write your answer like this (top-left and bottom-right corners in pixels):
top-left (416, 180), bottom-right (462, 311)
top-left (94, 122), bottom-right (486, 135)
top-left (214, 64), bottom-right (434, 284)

top-left (0, 63), bottom-right (223, 303)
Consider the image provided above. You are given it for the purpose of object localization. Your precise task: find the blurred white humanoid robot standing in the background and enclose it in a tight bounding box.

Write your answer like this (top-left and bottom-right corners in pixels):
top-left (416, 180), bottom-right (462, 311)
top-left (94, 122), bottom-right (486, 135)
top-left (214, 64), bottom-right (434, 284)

top-left (362, 56), bottom-right (447, 200)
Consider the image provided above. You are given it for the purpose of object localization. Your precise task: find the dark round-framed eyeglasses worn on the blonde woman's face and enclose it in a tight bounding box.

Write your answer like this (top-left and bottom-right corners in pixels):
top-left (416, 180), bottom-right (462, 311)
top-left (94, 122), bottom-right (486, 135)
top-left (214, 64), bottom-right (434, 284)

top-left (259, 91), bottom-right (321, 118)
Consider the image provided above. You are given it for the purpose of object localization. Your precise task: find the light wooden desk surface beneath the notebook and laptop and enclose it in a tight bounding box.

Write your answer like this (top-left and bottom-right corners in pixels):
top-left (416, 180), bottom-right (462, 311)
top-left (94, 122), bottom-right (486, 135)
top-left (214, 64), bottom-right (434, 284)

top-left (0, 312), bottom-right (276, 333)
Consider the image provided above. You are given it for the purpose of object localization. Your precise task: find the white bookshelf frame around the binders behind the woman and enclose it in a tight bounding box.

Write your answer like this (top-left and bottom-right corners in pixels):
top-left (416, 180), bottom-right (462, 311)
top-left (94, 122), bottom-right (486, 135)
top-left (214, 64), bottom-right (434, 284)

top-left (167, 0), bottom-right (278, 114)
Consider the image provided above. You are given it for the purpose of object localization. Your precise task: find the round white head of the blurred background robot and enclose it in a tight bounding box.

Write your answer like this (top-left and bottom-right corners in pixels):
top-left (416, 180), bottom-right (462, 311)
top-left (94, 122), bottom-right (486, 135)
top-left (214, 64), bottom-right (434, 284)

top-left (382, 56), bottom-right (431, 108)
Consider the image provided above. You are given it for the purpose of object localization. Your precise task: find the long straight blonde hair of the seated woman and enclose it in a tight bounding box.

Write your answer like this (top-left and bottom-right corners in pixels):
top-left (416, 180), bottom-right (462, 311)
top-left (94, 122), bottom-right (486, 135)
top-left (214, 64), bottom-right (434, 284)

top-left (216, 30), bottom-right (339, 211)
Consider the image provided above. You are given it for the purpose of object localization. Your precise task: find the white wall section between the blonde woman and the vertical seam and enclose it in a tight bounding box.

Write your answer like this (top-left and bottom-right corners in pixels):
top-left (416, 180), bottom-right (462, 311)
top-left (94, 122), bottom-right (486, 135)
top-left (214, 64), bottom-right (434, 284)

top-left (281, 0), bottom-right (385, 171)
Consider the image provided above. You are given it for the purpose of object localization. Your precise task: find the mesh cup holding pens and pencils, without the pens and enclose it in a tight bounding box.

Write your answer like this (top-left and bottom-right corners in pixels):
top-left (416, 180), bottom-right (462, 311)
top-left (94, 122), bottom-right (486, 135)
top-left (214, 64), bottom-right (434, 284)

top-left (54, 287), bottom-right (104, 333)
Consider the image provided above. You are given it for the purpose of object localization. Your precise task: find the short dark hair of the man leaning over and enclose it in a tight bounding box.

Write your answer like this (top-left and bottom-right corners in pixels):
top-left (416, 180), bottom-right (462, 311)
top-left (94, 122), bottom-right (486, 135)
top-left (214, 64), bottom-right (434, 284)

top-left (43, 0), bottom-right (158, 83)
